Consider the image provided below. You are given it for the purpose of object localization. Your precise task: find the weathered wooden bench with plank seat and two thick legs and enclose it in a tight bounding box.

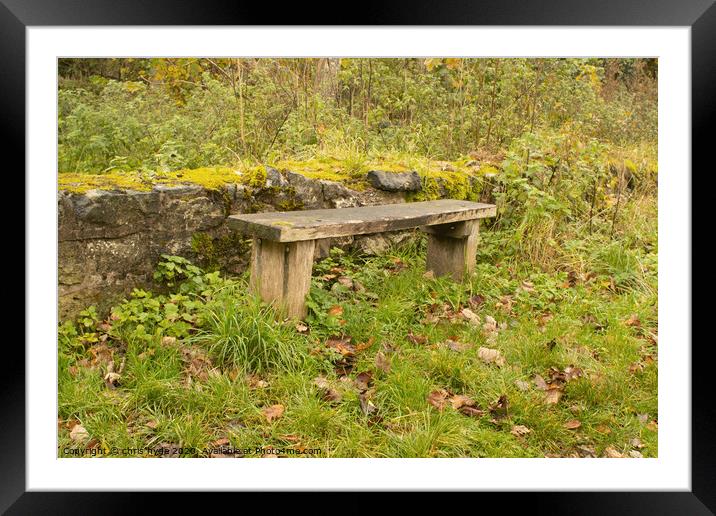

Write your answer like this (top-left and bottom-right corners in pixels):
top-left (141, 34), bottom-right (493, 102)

top-left (229, 199), bottom-right (495, 319)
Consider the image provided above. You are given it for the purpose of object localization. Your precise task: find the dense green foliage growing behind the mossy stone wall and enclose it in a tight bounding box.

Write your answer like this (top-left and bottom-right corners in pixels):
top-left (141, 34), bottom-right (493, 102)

top-left (58, 58), bottom-right (657, 172)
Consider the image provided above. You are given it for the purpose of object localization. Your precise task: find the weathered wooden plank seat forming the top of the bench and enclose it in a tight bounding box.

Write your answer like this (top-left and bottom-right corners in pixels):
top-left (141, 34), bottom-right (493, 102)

top-left (229, 199), bottom-right (496, 242)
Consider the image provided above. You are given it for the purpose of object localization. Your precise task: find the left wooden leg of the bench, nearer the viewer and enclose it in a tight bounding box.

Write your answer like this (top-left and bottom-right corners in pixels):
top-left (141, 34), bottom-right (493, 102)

top-left (250, 238), bottom-right (316, 319)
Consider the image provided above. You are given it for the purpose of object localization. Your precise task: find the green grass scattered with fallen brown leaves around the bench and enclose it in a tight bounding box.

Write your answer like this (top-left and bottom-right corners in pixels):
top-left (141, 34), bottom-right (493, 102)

top-left (58, 217), bottom-right (658, 457)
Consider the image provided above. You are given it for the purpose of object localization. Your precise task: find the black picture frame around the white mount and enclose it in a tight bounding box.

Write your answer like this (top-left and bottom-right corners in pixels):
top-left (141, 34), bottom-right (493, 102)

top-left (5, 0), bottom-right (716, 514)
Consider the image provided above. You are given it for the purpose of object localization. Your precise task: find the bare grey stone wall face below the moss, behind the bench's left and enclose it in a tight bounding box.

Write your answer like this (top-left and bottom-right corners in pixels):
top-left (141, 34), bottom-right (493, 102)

top-left (57, 168), bottom-right (420, 320)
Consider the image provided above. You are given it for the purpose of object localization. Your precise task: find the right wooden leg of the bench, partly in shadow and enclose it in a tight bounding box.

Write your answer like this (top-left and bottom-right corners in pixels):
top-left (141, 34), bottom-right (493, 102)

top-left (423, 220), bottom-right (480, 281)
